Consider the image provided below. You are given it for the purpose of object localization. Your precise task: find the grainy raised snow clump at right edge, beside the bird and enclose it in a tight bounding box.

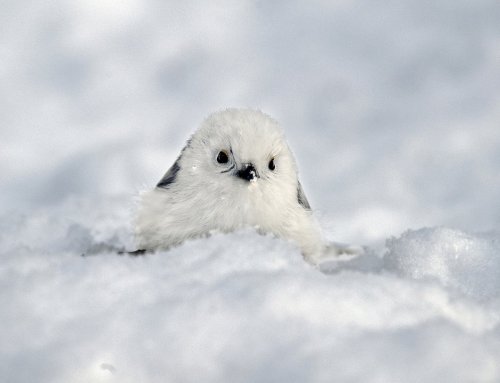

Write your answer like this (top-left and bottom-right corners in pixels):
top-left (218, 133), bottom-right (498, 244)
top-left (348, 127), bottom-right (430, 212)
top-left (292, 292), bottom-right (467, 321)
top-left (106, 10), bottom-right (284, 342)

top-left (385, 227), bottom-right (500, 299)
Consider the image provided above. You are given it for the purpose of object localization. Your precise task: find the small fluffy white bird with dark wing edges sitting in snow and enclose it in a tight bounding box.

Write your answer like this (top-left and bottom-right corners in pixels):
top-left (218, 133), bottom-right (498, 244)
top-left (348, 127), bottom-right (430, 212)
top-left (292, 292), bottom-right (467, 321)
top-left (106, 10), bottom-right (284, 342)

top-left (136, 109), bottom-right (348, 263)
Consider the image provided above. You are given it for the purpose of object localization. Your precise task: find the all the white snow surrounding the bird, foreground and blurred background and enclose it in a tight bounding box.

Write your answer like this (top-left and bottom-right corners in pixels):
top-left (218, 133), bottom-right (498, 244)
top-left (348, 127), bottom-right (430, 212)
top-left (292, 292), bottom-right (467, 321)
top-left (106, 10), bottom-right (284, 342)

top-left (0, 0), bottom-right (500, 383)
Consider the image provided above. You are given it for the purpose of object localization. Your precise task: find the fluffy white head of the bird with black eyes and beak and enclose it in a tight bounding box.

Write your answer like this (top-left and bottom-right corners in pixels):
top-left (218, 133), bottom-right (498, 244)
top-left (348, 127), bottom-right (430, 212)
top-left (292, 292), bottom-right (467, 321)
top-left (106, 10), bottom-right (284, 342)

top-left (189, 109), bottom-right (297, 188)
